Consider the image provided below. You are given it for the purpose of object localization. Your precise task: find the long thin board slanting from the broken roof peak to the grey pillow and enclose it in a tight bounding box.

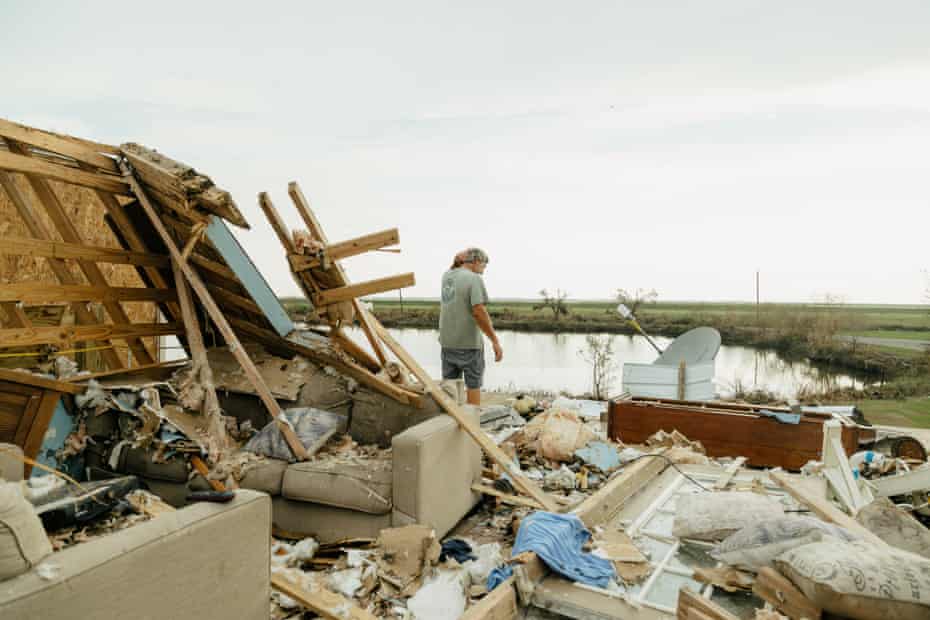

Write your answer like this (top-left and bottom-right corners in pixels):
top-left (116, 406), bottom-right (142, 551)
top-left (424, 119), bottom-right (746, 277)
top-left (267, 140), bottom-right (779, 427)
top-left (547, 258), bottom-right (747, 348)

top-left (123, 164), bottom-right (307, 460)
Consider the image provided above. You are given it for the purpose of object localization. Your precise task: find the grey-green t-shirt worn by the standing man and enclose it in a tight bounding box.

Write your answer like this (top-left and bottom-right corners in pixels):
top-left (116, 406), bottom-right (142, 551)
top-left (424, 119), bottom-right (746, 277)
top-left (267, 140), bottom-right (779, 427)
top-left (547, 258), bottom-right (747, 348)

top-left (439, 267), bottom-right (488, 349)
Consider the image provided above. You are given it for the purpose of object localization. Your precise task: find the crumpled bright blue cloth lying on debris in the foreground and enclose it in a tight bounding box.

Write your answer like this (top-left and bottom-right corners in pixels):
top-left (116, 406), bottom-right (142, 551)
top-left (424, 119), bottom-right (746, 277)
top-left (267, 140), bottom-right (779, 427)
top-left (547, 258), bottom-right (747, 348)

top-left (488, 511), bottom-right (616, 590)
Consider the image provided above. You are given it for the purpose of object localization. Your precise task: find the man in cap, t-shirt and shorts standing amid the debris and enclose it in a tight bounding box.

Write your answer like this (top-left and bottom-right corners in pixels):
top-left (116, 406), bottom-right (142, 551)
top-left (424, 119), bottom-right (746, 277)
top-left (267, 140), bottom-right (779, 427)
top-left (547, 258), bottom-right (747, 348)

top-left (439, 248), bottom-right (504, 405)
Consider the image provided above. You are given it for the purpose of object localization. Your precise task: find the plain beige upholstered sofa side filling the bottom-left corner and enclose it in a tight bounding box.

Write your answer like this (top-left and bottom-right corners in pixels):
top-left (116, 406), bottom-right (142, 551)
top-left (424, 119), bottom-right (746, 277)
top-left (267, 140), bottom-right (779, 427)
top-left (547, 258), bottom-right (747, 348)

top-left (0, 490), bottom-right (271, 620)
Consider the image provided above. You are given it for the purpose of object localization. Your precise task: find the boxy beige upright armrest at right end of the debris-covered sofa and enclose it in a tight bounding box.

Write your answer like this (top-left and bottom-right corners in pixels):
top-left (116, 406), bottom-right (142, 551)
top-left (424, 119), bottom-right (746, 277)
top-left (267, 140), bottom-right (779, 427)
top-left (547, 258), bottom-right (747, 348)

top-left (392, 408), bottom-right (481, 537)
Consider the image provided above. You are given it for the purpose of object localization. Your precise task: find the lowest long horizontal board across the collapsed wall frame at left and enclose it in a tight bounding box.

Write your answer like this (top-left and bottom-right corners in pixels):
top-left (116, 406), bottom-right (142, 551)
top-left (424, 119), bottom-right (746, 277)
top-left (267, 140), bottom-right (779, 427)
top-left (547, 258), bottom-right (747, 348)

top-left (0, 323), bottom-right (182, 348)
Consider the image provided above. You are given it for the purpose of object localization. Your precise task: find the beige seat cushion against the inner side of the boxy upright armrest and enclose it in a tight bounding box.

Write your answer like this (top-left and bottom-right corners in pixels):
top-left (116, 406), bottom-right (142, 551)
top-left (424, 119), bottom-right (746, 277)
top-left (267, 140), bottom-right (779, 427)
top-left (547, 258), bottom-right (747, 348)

top-left (281, 457), bottom-right (393, 515)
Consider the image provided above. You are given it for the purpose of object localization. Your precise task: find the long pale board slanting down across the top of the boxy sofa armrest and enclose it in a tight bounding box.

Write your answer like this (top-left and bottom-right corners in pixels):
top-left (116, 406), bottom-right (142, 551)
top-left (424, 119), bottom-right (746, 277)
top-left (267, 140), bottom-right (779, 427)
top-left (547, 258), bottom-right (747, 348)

top-left (374, 321), bottom-right (558, 512)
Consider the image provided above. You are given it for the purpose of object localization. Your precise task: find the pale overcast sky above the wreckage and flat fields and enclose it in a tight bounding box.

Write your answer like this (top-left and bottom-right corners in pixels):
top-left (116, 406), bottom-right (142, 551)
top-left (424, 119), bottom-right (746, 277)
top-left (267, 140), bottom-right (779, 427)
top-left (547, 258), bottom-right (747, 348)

top-left (0, 0), bottom-right (930, 303)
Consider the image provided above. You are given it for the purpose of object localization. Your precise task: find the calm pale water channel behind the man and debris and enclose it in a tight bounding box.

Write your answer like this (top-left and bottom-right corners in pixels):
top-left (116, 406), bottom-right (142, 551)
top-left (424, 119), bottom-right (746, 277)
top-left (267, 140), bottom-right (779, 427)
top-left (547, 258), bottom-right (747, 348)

top-left (353, 329), bottom-right (861, 397)
